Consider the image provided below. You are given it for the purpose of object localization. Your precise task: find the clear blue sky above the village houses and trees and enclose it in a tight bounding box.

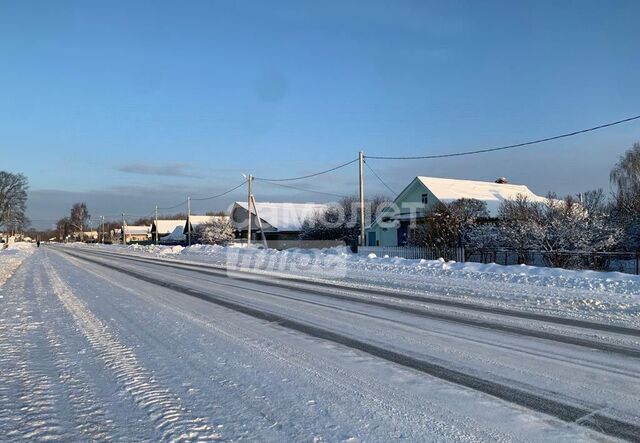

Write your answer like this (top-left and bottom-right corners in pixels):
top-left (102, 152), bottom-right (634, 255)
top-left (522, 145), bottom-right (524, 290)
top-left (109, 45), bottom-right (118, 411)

top-left (0, 0), bottom-right (640, 227)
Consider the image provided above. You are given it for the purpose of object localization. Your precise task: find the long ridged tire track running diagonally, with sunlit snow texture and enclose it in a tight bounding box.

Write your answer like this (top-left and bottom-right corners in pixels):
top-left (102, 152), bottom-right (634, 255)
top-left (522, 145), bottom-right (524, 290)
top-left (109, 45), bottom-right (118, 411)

top-left (45, 255), bottom-right (222, 442)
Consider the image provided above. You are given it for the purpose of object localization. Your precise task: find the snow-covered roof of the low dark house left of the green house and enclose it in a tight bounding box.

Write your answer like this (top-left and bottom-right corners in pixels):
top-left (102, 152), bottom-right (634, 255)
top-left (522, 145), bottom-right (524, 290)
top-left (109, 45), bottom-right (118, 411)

top-left (231, 202), bottom-right (329, 232)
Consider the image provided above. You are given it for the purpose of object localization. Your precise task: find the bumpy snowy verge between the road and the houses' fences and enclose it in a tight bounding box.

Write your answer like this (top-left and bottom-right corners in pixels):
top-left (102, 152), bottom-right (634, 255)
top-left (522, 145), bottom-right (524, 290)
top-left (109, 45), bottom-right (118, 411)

top-left (72, 245), bottom-right (640, 326)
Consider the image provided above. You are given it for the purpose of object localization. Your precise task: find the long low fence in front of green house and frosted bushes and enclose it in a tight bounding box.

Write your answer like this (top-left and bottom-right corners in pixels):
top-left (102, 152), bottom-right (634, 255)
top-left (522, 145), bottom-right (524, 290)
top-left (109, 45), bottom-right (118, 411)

top-left (358, 246), bottom-right (640, 275)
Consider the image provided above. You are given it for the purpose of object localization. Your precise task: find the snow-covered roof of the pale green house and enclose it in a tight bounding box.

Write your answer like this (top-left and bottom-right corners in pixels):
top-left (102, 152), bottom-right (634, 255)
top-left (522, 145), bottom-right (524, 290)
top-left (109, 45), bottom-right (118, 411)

top-left (417, 176), bottom-right (546, 216)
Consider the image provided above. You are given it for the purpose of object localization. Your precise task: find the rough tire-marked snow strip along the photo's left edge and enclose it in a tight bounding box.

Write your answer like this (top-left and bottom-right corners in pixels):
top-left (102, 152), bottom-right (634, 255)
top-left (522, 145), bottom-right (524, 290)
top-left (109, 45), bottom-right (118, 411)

top-left (0, 258), bottom-right (66, 441)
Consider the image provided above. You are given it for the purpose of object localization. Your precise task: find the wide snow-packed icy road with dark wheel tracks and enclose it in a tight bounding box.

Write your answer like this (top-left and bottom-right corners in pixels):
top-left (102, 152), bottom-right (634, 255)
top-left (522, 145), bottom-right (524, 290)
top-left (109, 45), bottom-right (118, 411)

top-left (0, 247), bottom-right (640, 442)
